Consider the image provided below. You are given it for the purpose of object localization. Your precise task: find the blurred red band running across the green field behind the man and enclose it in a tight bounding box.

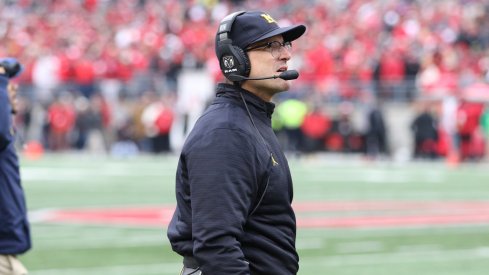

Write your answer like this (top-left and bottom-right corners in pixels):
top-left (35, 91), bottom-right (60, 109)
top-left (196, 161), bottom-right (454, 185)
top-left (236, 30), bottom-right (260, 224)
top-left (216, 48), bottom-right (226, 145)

top-left (29, 201), bottom-right (489, 229)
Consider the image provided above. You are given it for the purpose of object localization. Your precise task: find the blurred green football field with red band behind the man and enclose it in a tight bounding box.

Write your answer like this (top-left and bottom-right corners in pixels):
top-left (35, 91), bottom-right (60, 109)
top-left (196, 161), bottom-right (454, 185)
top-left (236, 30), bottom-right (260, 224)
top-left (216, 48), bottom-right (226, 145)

top-left (17, 154), bottom-right (489, 275)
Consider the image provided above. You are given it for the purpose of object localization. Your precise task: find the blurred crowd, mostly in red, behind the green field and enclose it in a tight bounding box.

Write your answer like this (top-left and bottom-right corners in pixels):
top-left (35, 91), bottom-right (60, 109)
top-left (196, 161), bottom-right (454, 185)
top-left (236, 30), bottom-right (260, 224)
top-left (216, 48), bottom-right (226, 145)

top-left (0, 0), bottom-right (489, 161)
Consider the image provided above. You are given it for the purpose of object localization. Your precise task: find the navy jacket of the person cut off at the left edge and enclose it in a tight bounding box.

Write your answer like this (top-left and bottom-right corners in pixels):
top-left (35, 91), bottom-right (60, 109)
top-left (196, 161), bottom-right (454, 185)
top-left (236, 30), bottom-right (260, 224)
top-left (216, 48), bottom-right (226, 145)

top-left (0, 76), bottom-right (31, 255)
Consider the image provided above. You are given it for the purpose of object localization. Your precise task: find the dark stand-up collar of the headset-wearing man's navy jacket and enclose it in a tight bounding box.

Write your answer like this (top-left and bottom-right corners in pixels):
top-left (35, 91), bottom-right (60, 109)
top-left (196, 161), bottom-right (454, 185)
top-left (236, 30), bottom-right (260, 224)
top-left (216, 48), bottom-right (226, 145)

top-left (216, 83), bottom-right (275, 118)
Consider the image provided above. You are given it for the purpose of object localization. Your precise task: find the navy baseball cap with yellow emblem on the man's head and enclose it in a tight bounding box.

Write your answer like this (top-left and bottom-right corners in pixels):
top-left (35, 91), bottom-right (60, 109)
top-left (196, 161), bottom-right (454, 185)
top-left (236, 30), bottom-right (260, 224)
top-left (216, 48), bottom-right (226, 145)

top-left (218, 11), bottom-right (306, 49)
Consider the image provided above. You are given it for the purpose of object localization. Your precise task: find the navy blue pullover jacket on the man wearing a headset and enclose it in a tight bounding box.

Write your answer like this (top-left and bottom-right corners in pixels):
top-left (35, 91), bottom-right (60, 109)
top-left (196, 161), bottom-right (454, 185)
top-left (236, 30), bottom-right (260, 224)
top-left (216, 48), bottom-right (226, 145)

top-left (168, 84), bottom-right (299, 275)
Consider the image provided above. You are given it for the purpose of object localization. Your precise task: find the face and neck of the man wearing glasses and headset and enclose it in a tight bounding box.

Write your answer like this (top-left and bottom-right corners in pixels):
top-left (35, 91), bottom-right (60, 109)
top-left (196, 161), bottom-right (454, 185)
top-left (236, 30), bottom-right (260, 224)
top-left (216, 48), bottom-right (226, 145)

top-left (242, 35), bottom-right (291, 101)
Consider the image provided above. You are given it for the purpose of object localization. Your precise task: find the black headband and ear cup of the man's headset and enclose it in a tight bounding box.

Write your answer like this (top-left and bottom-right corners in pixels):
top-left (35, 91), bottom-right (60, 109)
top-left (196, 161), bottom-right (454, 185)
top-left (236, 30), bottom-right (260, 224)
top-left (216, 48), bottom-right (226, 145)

top-left (216, 11), bottom-right (251, 82)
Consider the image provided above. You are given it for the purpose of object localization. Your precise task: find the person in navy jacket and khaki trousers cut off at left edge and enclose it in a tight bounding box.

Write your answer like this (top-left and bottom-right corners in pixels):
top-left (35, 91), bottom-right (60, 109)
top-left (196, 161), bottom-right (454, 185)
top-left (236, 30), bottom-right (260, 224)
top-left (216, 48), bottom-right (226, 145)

top-left (0, 58), bottom-right (31, 275)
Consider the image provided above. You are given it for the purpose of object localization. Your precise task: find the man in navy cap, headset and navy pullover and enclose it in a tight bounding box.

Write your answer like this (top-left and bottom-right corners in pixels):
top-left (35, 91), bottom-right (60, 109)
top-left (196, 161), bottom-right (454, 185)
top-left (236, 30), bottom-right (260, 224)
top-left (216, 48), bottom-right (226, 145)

top-left (168, 12), bottom-right (306, 275)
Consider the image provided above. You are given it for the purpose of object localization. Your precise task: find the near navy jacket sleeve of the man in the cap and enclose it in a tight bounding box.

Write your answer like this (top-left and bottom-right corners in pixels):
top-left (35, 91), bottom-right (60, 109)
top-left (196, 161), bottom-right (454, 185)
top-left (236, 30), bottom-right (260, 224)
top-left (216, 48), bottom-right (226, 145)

top-left (187, 129), bottom-right (258, 275)
